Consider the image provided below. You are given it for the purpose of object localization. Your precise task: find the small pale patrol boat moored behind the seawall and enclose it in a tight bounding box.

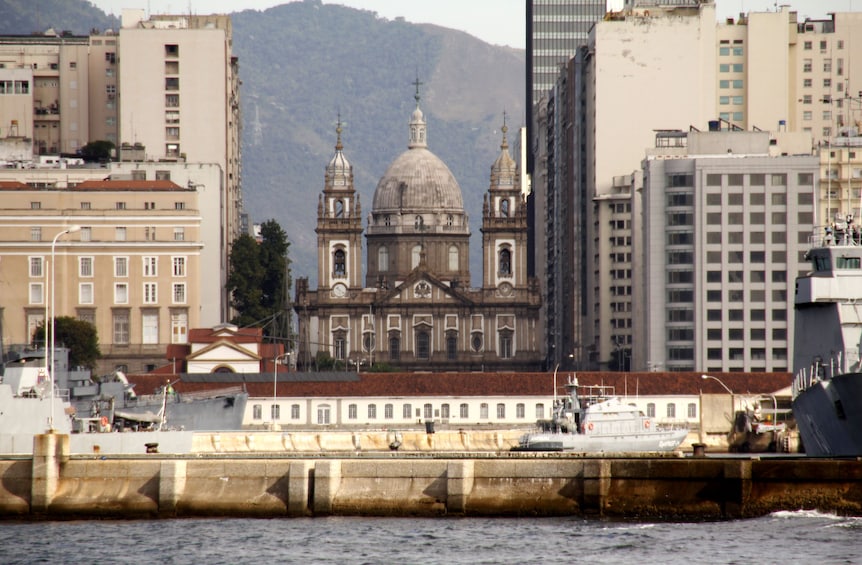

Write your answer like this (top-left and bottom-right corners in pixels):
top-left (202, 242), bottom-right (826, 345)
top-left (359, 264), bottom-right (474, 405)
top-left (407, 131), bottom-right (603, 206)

top-left (515, 379), bottom-right (688, 453)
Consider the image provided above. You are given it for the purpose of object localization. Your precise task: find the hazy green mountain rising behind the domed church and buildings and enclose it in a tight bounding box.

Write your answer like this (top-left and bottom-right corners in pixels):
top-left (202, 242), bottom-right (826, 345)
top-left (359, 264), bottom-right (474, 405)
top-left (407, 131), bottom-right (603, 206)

top-left (0, 0), bottom-right (525, 287)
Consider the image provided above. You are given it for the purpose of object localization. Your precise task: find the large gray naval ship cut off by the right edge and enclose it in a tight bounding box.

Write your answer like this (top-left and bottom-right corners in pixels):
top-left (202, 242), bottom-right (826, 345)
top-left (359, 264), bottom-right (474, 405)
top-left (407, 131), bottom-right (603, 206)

top-left (792, 216), bottom-right (862, 457)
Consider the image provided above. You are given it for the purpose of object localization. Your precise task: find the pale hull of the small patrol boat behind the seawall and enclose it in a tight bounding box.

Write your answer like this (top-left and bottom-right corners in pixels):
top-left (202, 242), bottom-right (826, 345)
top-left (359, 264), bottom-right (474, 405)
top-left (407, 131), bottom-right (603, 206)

top-left (515, 430), bottom-right (688, 453)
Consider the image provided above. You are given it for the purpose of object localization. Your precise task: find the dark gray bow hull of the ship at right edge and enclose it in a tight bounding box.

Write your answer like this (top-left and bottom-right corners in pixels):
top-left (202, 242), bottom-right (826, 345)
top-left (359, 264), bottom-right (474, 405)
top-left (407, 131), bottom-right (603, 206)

top-left (793, 373), bottom-right (862, 457)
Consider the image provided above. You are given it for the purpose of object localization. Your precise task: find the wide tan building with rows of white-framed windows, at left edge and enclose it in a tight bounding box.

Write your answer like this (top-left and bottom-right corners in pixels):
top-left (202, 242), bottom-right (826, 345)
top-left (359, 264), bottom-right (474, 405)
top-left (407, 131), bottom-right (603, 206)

top-left (0, 180), bottom-right (203, 372)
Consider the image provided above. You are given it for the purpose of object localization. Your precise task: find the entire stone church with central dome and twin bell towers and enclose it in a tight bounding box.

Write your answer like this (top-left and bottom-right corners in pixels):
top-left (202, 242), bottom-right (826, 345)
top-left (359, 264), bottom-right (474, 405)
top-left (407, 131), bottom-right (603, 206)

top-left (294, 90), bottom-right (542, 372)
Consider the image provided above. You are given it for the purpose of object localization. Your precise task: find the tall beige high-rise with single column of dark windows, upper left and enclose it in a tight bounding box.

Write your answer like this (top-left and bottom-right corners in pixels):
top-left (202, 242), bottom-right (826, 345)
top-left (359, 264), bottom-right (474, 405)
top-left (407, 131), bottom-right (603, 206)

top-left (118, 10), bottom-right (242, 294)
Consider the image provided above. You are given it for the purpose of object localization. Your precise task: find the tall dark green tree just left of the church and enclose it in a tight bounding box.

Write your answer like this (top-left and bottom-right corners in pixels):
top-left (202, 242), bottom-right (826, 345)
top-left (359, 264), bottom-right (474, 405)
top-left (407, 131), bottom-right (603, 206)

top-left (226, 220), bottom-right (291, 338)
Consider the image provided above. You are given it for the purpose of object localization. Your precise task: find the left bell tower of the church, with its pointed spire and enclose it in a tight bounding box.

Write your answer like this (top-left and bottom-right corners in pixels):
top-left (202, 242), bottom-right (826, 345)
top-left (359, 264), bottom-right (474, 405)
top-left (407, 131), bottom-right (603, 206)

top-left (314, 116), bottom-right (362, 298)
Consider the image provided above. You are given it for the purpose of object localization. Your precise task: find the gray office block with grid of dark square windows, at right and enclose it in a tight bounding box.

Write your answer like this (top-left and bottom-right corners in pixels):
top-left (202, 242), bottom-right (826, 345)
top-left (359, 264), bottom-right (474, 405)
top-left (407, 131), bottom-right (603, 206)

top-left (632, 130), bottom-right (819, 372)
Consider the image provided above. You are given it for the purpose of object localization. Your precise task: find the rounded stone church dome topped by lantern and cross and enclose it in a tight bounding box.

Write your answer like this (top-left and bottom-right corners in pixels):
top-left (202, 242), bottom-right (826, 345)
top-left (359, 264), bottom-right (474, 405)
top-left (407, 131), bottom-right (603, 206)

top-left (372, 84), bottom-right (464, 214)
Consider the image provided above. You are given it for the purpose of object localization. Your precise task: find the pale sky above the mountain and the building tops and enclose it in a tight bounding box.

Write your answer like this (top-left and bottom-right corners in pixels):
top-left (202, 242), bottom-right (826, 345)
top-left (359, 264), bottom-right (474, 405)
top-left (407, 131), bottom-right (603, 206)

top-left (90, 0), bottom-right (862, 49)
